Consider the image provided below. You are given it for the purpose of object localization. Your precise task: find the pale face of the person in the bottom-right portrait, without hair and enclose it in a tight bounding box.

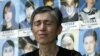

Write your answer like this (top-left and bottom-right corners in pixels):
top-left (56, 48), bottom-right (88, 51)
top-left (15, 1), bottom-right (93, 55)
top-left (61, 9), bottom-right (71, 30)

top-left (84, 36), bottom-right (96, 54)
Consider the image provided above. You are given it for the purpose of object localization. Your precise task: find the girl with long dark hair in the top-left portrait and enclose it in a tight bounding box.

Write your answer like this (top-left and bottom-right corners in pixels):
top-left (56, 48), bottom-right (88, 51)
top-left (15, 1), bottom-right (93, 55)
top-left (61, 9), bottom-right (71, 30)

top-left (2, 1), bottom-right (18, 31)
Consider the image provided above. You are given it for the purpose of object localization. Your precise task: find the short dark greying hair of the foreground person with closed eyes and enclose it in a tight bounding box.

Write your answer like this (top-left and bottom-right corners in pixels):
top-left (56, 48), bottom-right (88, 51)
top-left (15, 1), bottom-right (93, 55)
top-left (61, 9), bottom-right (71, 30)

top-left (31, 6), bottom-right (63, 26)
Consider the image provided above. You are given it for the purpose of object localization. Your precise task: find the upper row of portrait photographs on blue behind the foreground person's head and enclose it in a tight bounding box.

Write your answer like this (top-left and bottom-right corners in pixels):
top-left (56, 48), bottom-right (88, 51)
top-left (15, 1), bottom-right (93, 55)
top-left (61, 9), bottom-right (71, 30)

top-left (0, 0), bottom-right (100, 31)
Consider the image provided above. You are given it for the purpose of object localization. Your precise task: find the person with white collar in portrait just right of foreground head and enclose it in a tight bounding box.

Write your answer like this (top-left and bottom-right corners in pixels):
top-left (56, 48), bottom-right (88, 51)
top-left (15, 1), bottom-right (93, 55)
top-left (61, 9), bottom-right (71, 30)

top-left (61, 0), bottom-right (79, 22)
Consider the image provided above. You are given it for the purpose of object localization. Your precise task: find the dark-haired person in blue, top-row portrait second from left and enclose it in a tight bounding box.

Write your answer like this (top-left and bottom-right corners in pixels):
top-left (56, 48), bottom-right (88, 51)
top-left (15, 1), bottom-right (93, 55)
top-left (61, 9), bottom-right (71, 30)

top-left (19, 1), bottom-right (35, 29)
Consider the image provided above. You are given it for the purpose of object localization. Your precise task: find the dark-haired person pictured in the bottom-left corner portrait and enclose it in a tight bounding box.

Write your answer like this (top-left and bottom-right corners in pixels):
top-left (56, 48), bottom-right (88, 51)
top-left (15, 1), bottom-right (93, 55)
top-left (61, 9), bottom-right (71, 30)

top-left (2, 40), bottom-right (14, 56)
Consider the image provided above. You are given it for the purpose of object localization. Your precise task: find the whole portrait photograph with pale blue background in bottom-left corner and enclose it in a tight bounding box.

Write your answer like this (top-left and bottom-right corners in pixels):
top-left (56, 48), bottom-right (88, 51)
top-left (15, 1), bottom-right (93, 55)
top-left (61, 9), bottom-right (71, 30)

top-left (0, 38), bottom-right (18, 56)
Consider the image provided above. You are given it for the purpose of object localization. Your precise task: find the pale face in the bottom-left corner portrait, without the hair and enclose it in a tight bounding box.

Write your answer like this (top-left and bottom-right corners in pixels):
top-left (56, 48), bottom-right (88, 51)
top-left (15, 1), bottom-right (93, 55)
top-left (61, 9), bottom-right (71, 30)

top-left (3, 46), bottom-right (14, 56)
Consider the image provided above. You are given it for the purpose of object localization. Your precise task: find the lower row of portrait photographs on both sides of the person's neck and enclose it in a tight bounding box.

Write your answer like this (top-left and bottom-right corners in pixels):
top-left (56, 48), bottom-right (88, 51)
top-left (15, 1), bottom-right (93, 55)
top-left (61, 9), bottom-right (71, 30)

top-left (0, 28), bottom-right (100, 56)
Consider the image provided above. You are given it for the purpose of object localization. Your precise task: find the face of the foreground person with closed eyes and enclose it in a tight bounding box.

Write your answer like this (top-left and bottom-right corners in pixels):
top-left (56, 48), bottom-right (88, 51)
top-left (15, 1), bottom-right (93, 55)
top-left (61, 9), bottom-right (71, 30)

top-left (32, 12), bottom-right (62, 45)
